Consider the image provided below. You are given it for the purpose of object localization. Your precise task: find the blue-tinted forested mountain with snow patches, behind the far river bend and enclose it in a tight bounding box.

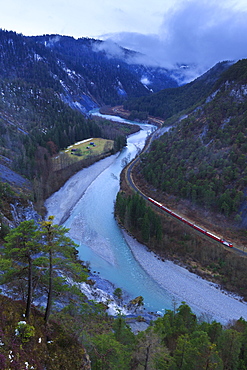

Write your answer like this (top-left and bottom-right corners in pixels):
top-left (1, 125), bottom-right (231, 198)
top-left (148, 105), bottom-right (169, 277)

top-left (0, 31), bottom-right (178, 113)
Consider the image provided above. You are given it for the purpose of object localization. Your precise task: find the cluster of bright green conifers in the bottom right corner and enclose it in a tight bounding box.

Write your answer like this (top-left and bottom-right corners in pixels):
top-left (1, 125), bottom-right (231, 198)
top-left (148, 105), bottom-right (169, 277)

top-left (132, 303), bottom-right (247, 370)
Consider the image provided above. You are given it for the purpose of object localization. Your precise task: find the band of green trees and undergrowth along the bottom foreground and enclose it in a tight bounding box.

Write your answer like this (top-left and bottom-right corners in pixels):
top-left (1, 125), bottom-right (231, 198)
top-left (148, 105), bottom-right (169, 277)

top-left (3, 294), bottom-right (247, 370)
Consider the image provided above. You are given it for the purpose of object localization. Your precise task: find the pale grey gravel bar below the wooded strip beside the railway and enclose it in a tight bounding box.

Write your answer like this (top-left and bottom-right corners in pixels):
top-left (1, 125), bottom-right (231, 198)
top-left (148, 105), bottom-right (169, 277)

top-left (123, 231), bottom-right (247, 324)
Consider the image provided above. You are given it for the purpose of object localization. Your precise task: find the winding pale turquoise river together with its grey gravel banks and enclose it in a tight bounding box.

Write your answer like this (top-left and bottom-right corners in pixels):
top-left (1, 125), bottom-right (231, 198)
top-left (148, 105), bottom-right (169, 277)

top-left (45, 111), bottom-right (247, 322)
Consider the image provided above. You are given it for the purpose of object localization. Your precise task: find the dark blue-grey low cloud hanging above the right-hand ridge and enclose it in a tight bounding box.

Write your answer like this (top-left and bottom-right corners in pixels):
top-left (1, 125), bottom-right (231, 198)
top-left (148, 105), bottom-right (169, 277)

top-left (103, 0), bottom-right (247, 78)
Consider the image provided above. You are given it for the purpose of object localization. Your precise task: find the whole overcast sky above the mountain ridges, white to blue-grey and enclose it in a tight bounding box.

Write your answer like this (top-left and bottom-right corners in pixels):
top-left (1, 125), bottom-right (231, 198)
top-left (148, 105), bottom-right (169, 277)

top-left (0, 0), bottom-right (247, 75)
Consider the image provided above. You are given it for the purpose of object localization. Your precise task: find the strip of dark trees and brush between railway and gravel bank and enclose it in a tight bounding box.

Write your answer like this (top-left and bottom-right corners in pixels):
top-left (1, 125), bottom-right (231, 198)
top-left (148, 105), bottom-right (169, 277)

top-left (115, 169), bottom-right (247, 299)
